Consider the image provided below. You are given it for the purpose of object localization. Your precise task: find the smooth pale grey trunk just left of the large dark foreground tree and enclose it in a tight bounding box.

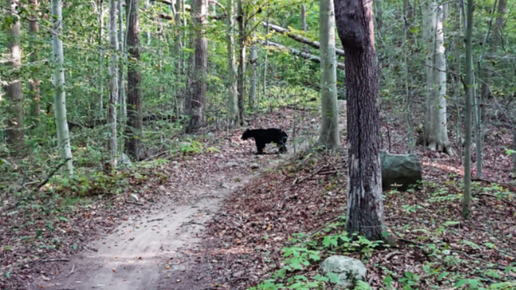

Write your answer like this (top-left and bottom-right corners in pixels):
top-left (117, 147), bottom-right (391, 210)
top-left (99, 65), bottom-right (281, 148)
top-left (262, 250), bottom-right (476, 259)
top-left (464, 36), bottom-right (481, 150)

top-left (319, 0), bottom-right (340, 149)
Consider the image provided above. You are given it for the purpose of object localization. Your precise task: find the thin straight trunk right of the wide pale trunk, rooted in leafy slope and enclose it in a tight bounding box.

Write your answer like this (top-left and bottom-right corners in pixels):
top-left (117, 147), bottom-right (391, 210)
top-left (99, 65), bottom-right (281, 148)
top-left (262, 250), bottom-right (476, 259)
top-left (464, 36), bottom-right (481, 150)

top-left (462, 0), bottom-right (474, 218)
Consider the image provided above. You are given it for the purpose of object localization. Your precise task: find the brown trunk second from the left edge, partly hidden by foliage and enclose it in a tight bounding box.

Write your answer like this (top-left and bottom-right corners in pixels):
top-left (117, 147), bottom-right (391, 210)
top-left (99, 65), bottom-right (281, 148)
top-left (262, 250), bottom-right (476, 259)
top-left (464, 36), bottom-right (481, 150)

top-left (29, 0), bottom-right (41, 123)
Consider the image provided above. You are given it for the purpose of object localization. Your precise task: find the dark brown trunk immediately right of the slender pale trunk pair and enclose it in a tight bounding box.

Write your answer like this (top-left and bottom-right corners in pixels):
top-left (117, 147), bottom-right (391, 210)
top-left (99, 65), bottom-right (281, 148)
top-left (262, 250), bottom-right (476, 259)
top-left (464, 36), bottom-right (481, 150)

top-left (125, 0), bottom-right (143, 160)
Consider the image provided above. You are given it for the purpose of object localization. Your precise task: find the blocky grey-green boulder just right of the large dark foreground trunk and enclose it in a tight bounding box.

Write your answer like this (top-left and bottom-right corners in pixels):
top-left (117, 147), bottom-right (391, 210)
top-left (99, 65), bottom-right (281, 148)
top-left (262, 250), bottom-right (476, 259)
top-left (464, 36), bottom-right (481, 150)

top-left (380, 151), bottom-right (423, 190)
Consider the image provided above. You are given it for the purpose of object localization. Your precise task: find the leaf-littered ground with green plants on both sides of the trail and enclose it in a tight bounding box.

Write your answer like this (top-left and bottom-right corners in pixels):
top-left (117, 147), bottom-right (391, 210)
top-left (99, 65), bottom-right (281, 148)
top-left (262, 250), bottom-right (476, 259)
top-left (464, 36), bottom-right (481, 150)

top-left (0, 108), bottom-right (516, 289)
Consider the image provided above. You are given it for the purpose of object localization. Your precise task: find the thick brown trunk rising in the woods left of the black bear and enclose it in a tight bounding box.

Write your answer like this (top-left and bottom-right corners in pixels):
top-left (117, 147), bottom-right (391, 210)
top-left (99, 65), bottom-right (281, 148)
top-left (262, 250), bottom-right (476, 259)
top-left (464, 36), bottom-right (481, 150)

top-left (185, 0), bottom-right (208, 133)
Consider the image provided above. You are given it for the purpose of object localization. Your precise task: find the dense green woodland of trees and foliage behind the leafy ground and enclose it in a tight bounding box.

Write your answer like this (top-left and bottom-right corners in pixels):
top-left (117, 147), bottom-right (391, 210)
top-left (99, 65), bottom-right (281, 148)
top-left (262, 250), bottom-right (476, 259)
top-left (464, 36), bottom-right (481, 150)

top-left (0, 0), bottom-right (516, 287)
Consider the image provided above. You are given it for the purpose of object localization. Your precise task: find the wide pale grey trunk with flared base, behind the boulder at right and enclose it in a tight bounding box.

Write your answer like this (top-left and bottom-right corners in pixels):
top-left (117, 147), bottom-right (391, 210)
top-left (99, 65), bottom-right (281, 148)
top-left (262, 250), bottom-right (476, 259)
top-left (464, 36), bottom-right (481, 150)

top-left (421, 0), bottom-right (453, 155)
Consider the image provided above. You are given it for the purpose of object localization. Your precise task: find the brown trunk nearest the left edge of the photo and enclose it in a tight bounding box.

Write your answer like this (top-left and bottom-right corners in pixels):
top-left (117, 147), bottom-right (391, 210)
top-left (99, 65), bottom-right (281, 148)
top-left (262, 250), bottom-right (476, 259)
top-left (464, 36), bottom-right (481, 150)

top-left (5, 0), bottom-right (23, 151)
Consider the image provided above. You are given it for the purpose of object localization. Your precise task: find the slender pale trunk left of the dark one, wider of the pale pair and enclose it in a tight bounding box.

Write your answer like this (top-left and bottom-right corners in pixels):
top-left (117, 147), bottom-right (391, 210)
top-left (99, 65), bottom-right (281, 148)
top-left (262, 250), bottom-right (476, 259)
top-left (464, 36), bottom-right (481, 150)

top-left (108, 0), bottom-right (118, 168)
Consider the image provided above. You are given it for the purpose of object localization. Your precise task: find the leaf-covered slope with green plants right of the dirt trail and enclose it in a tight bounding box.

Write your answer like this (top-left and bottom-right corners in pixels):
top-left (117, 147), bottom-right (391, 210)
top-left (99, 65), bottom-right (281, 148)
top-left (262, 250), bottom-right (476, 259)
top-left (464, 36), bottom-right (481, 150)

top-left (177, 110), bottom-right (516, 289)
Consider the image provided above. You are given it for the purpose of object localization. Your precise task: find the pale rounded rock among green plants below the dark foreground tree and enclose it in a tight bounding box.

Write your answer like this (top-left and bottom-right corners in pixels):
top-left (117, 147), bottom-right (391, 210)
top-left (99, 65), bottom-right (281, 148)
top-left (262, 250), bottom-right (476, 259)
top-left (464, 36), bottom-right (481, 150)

top-left (321, 256), bottom-right (367, 288)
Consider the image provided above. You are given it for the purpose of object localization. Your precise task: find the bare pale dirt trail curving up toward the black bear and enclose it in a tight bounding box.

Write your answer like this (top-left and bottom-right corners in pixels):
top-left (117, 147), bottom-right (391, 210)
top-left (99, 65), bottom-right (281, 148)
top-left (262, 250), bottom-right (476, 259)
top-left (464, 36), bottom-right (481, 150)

top-left (28, 154), bottom-right (292, 290)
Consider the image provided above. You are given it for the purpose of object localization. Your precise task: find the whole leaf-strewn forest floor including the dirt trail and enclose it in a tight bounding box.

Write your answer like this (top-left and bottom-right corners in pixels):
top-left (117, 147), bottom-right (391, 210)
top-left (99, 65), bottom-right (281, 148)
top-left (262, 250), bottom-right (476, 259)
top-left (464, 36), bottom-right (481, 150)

top-left (0, 102), bottom-right (516, 290)
